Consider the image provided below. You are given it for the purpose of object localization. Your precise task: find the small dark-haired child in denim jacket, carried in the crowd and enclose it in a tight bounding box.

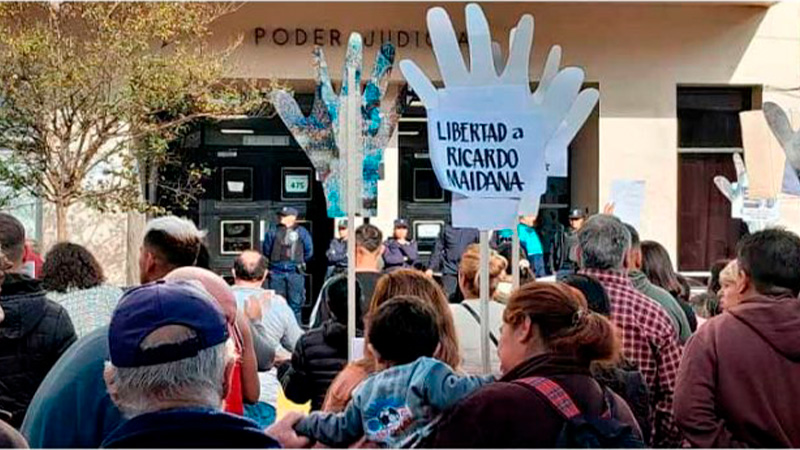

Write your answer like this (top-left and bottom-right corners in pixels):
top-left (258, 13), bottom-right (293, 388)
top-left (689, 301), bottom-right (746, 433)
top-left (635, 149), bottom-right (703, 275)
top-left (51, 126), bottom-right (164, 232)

top-left (295, 297), bottom-right (494, 448)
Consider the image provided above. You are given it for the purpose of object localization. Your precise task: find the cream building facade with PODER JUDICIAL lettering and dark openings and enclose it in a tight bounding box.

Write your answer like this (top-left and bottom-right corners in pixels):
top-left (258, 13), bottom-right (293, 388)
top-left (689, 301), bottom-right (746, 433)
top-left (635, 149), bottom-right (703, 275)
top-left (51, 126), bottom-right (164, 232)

top-left (20, 2), bottom-right (800, 284)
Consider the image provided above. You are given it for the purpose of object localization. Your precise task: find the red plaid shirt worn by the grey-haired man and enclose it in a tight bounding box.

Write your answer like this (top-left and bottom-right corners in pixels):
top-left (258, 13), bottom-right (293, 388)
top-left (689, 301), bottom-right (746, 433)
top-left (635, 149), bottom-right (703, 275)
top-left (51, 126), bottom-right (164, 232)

top-left (581, 269), bottom-right (682, 447)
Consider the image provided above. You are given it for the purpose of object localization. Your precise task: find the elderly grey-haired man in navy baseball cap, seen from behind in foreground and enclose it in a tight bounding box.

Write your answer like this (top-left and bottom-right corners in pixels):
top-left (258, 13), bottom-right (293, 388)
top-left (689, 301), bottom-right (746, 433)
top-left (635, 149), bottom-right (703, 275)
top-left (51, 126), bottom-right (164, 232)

top-left (102, 281), bottom-right (277, 448)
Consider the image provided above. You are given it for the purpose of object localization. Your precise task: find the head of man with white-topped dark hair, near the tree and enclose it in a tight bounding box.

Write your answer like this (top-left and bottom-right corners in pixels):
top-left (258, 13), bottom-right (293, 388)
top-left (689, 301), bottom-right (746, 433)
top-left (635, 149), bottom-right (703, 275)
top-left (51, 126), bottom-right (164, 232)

top-left (139, 216), bottom-right (205, 284)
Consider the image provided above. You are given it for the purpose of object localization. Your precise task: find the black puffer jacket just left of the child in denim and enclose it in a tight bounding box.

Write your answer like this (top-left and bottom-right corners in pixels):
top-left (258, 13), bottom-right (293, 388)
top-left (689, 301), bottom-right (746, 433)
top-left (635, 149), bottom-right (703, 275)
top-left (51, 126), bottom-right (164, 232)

top-left (281, 319), bottom-right (347, 410)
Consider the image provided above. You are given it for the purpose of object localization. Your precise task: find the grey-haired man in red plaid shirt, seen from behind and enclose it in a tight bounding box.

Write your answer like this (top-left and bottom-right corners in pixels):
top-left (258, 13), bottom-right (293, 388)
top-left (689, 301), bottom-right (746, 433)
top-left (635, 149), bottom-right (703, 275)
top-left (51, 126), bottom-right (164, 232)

top-left (578, 214), bottom-right (682, 448)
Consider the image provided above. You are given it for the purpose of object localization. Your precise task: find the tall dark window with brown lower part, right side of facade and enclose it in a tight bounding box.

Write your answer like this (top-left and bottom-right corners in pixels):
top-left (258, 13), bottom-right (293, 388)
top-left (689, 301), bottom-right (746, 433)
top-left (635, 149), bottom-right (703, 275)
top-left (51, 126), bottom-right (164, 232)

top-left (677, 87), bottom-right (757, 271)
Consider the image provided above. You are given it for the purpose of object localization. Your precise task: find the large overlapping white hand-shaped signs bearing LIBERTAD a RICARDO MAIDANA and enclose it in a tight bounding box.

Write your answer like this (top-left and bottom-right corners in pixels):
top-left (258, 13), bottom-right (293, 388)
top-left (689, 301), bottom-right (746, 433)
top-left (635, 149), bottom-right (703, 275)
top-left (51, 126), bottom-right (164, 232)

top-left (400, 4), bottom-right (599, 229)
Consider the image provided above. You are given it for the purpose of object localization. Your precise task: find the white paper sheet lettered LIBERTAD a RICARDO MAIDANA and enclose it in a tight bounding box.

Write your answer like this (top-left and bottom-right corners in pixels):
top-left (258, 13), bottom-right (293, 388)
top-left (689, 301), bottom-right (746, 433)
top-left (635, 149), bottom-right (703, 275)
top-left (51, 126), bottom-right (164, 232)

top-left (428, 86), bottom-right (547, 199)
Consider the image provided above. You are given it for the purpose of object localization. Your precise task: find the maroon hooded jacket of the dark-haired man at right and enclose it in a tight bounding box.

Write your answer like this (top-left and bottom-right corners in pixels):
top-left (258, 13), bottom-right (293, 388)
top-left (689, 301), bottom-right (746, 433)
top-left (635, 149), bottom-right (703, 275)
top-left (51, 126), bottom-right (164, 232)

top-left (674, 296), bottom-right (800, 448)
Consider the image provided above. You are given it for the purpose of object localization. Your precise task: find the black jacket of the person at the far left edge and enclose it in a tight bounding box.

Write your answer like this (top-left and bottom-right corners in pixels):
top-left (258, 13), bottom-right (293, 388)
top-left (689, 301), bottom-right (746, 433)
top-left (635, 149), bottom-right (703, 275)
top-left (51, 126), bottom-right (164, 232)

top-left (0, 274), bottom-right (77, 428)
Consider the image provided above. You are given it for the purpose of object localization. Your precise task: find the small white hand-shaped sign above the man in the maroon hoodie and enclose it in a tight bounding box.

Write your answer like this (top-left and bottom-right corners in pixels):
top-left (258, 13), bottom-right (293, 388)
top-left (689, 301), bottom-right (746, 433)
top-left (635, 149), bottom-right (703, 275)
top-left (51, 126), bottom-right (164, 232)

top-left (714, 153), bottom-right (780, 233)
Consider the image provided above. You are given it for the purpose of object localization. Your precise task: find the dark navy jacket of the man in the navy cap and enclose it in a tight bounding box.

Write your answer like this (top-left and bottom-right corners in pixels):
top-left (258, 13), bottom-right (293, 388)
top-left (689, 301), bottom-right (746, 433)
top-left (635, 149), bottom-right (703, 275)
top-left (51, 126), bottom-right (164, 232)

top-left (102, 408), bottom-right (280, 448)
